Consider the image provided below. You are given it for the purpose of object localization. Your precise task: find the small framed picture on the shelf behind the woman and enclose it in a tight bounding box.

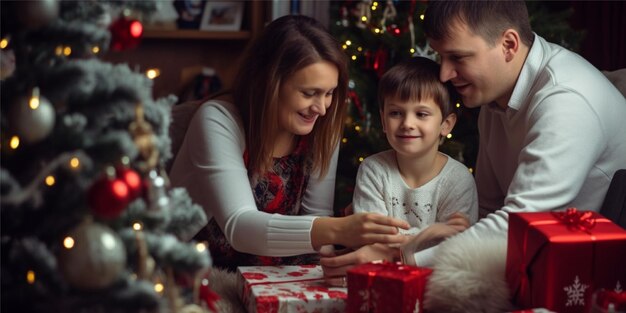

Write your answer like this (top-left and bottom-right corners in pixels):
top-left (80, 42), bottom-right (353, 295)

top-left (200, 0), bottom-right (244, 31)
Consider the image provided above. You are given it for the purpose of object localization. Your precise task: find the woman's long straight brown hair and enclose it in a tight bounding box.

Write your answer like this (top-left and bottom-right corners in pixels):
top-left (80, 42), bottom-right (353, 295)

top-left (233, 15), bottom-right (348, 177)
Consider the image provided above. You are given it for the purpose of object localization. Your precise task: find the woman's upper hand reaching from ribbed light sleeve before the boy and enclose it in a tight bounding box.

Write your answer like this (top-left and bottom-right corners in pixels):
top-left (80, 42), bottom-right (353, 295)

top-left (311, 213), bottom-right (409, 249)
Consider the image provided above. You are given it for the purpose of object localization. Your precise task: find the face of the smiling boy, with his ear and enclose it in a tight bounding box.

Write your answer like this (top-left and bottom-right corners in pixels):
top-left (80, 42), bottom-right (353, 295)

top-left (380, 97), bottom-right (456, 158)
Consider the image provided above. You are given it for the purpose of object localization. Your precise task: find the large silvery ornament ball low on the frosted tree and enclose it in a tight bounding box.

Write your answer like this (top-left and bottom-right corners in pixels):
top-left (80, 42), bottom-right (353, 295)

top-left (58, 222), bottom-right (126, 290)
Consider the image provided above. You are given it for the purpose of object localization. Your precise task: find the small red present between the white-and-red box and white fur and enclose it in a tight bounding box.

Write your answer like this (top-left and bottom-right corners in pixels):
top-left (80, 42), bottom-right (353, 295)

top-left (346, 262), bottom-right (433, 313)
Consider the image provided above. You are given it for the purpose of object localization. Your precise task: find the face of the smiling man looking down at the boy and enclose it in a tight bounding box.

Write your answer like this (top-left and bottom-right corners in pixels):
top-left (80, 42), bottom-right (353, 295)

top-left (429, 20), bottom-right (512, 108)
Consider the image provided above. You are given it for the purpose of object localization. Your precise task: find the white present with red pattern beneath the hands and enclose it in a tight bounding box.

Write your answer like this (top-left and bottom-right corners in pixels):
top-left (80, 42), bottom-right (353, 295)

top-left (237, 265), bottom-right (348, 313)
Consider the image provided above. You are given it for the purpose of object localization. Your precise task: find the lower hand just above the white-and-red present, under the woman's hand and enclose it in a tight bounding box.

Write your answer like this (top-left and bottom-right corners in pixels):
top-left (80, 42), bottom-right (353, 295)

top-left (320, 244), bottom-right (400, 287)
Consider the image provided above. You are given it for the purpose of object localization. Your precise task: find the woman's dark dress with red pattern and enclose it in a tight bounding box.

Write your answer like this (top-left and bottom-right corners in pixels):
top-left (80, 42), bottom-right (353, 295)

top-left (196, 136), bottom-right (319, 271)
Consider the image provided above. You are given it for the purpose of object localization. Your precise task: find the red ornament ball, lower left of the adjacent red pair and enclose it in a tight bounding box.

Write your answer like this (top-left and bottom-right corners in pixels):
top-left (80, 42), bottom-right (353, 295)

top-left (88, 177), bottom-right (131, 219)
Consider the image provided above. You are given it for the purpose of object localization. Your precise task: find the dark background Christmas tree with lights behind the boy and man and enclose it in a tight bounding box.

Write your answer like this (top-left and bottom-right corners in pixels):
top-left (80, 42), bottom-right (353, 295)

top-left (330, 0), bottom-right (584, 210)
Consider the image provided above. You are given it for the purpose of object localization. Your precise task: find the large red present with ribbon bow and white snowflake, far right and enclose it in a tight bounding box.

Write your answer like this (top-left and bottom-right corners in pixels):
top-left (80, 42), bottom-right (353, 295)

top-left (506, 208), bottom-right (626, 312)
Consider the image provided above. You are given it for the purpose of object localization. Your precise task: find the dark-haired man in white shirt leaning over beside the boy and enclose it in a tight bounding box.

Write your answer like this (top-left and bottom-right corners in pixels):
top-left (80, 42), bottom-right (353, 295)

top-left (322, 0), bottom-right (626, 276)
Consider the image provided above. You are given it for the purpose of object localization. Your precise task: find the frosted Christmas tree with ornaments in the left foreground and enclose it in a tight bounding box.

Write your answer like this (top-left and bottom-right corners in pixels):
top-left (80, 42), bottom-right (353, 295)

top-left (0, 0), bottom-right (215, 312)
